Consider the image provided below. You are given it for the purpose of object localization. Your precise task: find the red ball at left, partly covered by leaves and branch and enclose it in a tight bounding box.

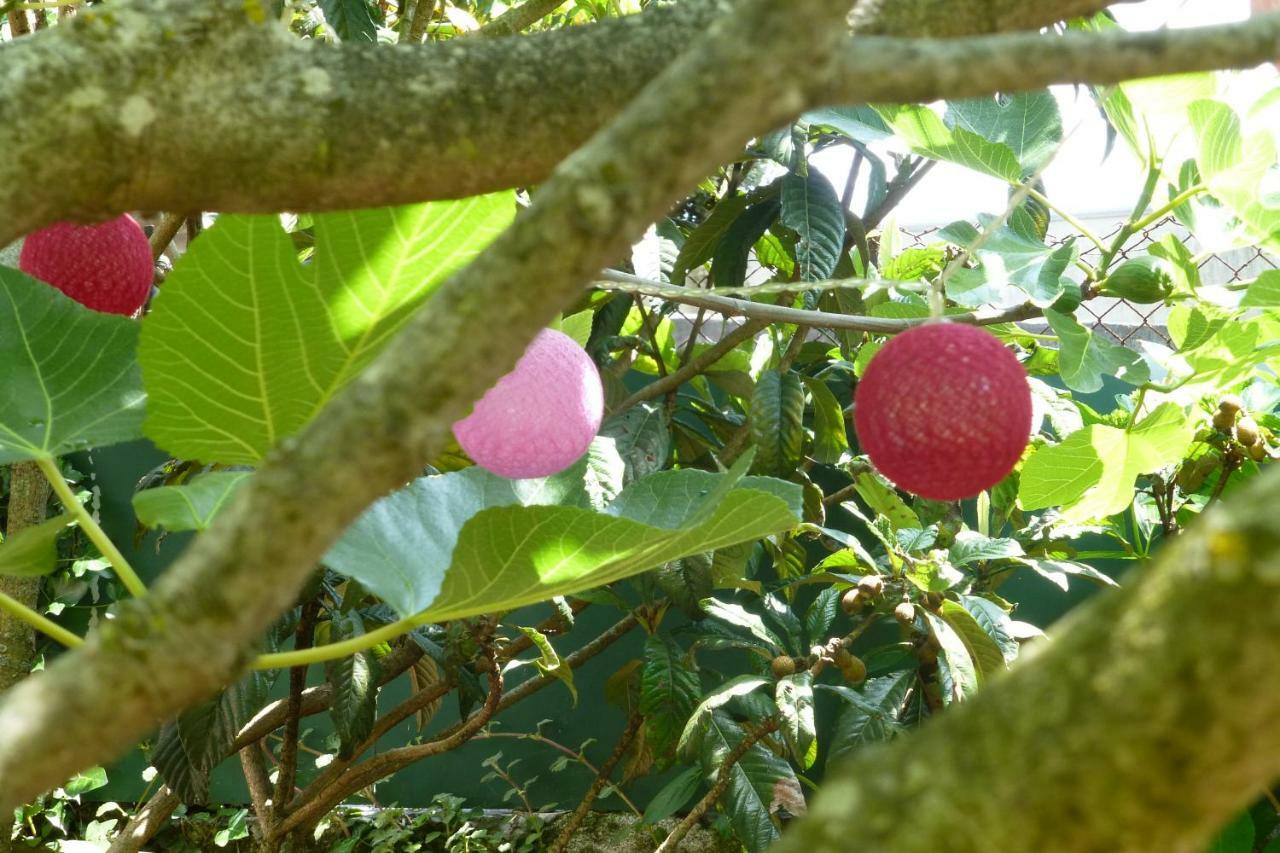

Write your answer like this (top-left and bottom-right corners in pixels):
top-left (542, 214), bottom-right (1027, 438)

top-left (18, 214), bottom-right (155, 316)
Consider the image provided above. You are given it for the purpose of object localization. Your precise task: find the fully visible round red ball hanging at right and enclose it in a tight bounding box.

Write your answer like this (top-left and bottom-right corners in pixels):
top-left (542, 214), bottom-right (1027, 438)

top-left (854, 323), bottom-right (1032, 501)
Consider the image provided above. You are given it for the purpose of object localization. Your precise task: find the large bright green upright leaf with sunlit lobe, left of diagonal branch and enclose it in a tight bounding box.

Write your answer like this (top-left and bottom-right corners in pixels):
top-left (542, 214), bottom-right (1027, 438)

top-left (138, 193), bottom-right (515, 464)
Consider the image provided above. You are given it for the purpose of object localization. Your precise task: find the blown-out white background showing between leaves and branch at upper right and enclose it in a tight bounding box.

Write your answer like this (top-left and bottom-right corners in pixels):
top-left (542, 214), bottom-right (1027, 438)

top-left (815, 0), bottom-right (1277, 228)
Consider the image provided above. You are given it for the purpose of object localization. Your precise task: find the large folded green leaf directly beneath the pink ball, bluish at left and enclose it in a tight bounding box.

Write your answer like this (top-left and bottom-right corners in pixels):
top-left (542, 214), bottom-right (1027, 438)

top-left (325, 453), bottom-right (800, 621)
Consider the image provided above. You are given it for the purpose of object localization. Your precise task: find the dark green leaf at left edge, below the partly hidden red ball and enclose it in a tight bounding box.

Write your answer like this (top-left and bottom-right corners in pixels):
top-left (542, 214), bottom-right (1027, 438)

top-left (0, 266), bottom-right (146, 465)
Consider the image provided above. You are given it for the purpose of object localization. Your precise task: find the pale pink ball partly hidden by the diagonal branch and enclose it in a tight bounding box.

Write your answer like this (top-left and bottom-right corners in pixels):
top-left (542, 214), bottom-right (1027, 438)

top-left (453, 329), bottom-right (604, 479)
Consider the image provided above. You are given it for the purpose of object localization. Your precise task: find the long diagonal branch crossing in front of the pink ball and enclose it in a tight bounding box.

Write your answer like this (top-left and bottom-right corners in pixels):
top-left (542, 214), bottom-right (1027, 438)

top-left (0, 0), bottom-right (846, 809)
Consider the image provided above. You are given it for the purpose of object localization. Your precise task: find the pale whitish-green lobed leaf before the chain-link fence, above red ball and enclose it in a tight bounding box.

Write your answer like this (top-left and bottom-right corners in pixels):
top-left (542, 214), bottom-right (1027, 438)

top-left (938, 216), bottom-right (1079, 307)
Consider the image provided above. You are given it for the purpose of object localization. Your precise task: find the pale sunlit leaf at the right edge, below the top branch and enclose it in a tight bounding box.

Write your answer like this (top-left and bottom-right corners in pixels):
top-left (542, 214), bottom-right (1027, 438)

top-left (1188, 100), bottom-right (1280, 251)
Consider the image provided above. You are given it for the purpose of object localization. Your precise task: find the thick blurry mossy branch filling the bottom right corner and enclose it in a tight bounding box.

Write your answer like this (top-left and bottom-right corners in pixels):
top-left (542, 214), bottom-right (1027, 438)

top-left (777, 470), bottom-right (1280, 853)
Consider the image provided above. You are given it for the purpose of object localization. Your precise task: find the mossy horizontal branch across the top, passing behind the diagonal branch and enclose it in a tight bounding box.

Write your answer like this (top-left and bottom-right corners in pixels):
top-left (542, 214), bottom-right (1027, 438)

top-left (0, 0), bottom-right (1280, 245)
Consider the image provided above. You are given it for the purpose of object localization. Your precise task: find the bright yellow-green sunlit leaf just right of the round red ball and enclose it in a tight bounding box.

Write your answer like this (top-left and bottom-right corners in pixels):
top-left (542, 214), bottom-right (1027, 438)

top-left (1018, 403), bottom-right (1194, 519)
